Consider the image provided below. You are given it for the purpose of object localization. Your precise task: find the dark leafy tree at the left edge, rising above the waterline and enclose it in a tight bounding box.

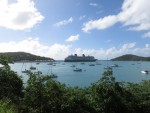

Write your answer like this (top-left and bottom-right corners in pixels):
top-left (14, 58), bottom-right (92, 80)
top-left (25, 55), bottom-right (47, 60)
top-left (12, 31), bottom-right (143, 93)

top-left (0, 56), bottom-right (23, 111)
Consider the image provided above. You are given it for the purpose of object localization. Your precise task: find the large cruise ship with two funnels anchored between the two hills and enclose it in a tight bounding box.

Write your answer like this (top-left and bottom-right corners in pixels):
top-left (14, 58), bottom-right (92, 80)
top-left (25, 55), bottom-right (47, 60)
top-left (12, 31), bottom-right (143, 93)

top-left (64, 54), bottom-right (97, 62)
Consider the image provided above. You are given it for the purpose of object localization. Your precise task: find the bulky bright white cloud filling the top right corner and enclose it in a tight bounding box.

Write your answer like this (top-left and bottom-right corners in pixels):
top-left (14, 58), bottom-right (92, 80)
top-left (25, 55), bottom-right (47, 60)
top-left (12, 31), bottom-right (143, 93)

top-left (117, 0), bottom-right (150, 31)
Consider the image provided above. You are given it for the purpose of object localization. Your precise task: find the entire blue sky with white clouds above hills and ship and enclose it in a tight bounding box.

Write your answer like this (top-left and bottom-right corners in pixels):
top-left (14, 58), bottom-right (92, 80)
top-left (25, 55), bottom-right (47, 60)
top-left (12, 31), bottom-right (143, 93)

top-left (0, 0), bottom-right (150, 60)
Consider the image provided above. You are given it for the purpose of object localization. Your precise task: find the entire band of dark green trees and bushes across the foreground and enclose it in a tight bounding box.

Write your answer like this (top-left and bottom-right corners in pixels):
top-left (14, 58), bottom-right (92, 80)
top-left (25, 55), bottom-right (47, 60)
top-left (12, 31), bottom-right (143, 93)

top-left (0, 57), bottom-right (150, 113)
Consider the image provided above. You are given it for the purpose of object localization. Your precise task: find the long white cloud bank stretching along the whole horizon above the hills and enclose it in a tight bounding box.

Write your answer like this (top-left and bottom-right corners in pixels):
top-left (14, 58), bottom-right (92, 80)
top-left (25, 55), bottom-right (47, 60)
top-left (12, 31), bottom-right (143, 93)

top-left (0, 38), bottom-right (150, 60)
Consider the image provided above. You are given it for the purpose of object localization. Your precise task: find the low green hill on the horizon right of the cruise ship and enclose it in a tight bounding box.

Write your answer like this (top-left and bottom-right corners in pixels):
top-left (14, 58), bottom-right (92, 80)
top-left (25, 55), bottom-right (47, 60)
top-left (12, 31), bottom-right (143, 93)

top-left (111, 54), bottom-right (150, 61)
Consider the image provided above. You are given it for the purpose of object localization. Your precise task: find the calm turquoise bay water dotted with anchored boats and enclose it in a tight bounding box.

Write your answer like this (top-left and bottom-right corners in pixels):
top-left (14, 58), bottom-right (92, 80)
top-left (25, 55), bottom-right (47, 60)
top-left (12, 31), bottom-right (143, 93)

top-left (10, 61), bottom-right (150, 87)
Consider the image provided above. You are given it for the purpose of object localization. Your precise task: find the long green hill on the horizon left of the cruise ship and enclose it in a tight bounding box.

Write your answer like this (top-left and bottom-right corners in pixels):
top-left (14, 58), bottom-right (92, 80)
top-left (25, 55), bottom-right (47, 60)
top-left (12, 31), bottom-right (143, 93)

top-left (0, 52), bottom-right (54, 62)
